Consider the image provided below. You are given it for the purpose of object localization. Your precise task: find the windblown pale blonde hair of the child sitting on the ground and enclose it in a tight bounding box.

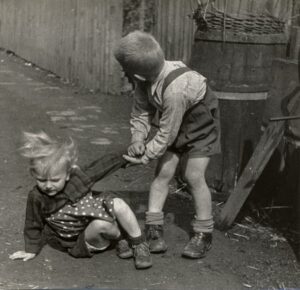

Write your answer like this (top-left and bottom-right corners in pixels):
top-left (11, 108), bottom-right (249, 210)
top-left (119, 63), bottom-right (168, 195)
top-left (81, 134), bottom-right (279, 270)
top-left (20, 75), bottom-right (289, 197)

top-left (20, 132), bottom-right (78, 175)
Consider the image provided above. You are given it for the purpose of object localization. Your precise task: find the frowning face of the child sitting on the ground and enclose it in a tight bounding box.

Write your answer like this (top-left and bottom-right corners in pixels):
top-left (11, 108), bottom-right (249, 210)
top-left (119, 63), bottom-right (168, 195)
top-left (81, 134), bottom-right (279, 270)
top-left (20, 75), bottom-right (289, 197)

top-left (32, 166), bottom-right (69, 196)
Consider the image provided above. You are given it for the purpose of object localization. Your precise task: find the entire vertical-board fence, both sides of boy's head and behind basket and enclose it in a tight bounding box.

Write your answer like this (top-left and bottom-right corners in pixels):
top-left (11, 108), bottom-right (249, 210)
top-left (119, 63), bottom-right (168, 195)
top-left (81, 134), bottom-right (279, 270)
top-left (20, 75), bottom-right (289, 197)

top-left (0, 0), bottom-right (294, 94)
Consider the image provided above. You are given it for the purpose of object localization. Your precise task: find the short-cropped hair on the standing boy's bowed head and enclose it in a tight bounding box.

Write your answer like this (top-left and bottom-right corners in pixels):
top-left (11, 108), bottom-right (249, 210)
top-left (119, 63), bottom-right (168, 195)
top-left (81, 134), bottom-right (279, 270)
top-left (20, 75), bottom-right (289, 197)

top-left (114, 30), bottom-right (165, 76)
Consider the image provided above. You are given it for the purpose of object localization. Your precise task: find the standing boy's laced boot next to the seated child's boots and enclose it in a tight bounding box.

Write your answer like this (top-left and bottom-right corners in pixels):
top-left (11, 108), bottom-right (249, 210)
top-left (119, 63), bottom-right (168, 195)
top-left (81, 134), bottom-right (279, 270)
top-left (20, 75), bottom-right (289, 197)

top-left (146, 225), bottom-right (168, 253)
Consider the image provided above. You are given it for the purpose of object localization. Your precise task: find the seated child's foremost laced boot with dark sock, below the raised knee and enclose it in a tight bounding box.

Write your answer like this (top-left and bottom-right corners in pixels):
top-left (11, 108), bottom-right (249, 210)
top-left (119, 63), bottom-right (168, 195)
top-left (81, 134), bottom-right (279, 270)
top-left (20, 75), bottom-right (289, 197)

top-left (130, 236), bottom-right (152, 269)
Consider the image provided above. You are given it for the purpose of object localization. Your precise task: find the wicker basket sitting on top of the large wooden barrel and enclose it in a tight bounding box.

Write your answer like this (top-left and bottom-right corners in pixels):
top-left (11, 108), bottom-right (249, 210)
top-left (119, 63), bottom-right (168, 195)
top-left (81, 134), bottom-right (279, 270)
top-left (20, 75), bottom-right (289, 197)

top-left (193, 6), bottom-right (285, 35)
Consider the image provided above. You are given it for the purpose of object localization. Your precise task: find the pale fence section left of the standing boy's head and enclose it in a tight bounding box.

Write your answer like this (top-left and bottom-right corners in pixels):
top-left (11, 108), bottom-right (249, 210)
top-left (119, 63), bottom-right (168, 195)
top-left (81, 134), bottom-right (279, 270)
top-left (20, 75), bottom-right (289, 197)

top-left (0, 0), bottom-right (123, 94)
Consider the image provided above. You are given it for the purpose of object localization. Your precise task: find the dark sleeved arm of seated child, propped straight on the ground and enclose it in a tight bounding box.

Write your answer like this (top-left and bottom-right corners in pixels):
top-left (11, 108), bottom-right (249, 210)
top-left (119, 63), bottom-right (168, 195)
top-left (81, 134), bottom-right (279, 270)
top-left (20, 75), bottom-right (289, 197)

top-left (24, 190), bottom-right (45, 255)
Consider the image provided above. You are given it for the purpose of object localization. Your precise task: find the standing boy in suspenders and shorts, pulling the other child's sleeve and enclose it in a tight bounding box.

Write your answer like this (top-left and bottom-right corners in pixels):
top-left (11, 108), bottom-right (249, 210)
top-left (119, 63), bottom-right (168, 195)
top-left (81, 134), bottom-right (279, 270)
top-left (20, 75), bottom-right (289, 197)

top-left (115, 31), bottom-right (220, 258)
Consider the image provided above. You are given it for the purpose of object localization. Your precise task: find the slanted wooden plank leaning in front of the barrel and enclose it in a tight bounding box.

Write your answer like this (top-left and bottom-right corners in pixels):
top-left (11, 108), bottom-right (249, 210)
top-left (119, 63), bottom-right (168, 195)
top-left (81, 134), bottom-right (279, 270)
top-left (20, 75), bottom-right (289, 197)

top-left (217, 87), bottom-right (300, 229)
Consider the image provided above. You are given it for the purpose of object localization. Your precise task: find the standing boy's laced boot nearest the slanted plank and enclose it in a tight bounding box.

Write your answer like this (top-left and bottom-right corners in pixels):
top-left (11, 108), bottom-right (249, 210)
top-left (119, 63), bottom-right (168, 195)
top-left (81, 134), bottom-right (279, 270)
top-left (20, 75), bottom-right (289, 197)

top-left (182, 233), bottom-right (212, 259)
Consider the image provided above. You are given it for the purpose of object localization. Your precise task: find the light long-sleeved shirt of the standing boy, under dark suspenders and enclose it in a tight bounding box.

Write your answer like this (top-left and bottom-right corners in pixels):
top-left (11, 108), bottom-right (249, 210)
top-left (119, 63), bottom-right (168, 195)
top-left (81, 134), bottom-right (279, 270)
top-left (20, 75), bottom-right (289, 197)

top-left (130, 61), bottom-right (206, 159)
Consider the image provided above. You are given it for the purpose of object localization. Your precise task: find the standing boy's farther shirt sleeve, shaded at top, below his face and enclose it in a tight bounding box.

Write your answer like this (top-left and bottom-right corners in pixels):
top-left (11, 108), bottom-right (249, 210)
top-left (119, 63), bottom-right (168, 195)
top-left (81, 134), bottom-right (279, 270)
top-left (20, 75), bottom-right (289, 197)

top-left (130, 85), bottom-right (156, 143)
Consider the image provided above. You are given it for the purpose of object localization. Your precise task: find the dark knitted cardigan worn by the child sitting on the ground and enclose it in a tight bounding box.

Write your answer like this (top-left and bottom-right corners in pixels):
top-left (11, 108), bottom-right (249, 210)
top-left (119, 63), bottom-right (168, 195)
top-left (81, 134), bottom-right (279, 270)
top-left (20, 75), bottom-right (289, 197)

top-left (24, 154), bottom-right (127, 254)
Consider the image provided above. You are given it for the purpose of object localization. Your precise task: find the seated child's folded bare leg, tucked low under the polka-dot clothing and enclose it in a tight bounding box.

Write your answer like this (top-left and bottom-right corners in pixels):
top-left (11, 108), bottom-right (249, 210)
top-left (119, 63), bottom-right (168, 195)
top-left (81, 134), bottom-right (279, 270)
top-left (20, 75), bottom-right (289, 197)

top-left (85, 219), bottom-right (120, 249)
